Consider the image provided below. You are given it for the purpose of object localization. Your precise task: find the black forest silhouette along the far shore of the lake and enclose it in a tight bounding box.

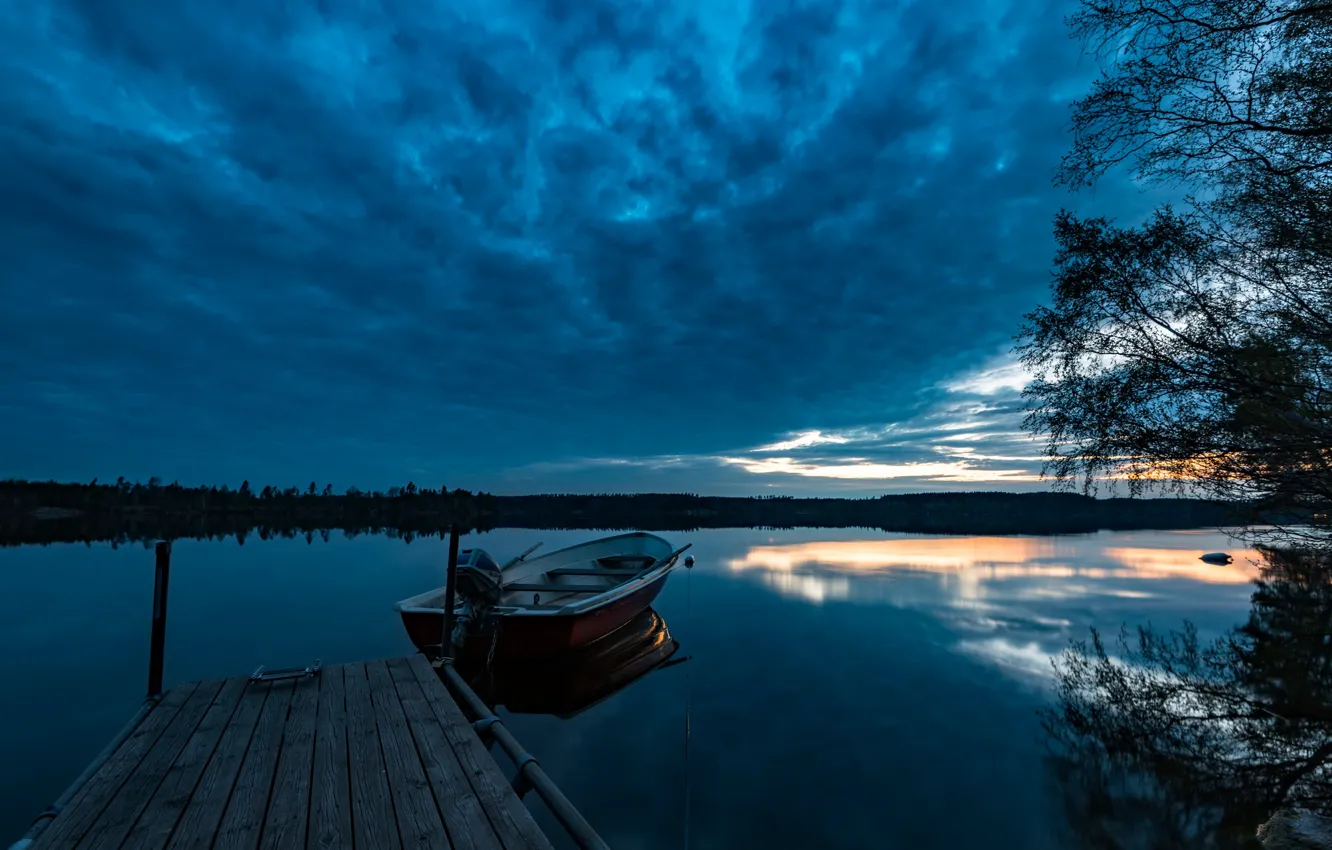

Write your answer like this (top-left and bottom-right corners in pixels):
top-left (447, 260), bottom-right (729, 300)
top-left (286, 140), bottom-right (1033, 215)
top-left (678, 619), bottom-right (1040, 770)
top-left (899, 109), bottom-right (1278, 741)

top-left (0, 478), bottom-right (1268, 545)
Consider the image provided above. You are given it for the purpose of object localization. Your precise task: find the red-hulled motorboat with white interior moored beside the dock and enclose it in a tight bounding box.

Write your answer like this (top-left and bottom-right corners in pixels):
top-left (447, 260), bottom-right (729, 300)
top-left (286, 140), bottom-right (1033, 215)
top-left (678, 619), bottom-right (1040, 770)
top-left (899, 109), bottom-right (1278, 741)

top-left (397, 532), bottom-right (689, 658)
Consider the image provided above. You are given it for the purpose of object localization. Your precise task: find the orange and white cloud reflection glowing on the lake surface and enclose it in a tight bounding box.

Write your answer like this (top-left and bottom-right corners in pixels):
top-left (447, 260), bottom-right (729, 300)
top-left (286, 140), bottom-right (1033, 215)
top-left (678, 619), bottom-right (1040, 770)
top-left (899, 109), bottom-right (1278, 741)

top-left (726, 532), bottom-right (1257, 678)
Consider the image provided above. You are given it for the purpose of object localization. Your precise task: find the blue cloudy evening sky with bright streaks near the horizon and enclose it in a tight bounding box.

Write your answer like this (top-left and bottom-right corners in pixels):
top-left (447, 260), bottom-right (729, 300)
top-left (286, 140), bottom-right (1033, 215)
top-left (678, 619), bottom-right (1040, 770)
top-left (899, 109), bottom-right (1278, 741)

top-left (0, 0), bottom-right (1154, 496)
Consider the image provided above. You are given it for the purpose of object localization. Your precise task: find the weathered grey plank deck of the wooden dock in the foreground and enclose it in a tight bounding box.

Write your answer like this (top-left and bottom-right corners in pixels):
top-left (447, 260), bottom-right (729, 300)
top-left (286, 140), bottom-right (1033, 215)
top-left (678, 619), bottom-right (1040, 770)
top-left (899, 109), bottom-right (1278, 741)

top-left (25, 655), bottom-right (551, 850)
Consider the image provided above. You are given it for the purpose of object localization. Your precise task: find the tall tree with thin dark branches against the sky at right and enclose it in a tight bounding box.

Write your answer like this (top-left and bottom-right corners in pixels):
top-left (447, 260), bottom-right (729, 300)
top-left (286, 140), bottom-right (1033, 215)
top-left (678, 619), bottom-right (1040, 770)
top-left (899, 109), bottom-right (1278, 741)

top-left (1018, 0), bottom-right (1332, 538)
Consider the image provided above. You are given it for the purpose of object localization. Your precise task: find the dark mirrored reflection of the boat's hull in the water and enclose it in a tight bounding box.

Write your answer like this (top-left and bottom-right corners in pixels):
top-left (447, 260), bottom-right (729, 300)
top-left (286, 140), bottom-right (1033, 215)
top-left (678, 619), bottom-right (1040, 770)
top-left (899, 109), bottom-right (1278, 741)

top-left (457, 608), bottom-right (689, 718)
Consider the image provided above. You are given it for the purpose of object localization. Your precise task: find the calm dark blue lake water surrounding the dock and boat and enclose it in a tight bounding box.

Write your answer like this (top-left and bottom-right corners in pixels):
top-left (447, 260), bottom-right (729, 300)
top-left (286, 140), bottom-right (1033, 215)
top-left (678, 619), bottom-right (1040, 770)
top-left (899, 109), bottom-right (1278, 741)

top-left (0, 529), bottom-right (1256, 850)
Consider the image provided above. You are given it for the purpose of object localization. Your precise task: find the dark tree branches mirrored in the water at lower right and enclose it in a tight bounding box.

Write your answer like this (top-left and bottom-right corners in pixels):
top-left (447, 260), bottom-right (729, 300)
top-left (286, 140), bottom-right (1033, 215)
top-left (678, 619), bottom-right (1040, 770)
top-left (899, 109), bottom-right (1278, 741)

top-left (1042, 549), bottom-right (1332, 850)
